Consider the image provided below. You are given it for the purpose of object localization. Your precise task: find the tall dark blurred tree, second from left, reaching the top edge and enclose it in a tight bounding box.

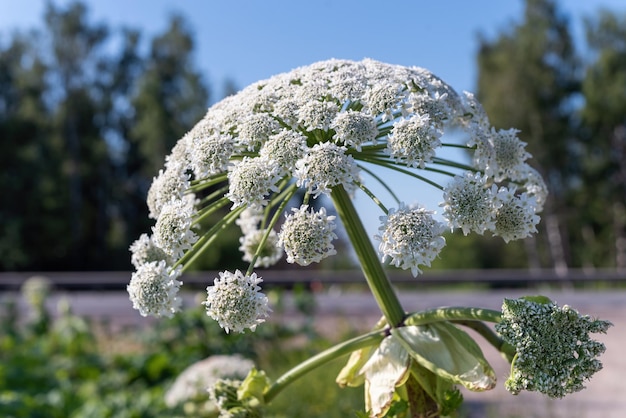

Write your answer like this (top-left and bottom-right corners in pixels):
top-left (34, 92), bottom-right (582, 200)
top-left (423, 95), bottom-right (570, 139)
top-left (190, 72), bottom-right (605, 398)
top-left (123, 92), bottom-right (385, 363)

top-left (42, 3), bottom-right (112, 269)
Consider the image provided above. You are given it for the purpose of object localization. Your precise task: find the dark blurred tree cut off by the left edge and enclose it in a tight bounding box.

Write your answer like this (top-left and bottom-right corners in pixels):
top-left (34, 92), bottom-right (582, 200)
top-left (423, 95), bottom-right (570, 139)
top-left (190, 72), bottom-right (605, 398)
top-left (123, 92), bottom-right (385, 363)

top-left (0, 35), bottom-right (49, 269)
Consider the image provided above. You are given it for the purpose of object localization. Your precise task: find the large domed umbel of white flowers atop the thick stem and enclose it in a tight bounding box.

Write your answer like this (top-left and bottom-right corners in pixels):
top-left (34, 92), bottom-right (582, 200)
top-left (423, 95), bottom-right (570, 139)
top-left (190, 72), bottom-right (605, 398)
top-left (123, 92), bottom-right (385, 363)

top-left (128, 59), bottom-right (547, 331)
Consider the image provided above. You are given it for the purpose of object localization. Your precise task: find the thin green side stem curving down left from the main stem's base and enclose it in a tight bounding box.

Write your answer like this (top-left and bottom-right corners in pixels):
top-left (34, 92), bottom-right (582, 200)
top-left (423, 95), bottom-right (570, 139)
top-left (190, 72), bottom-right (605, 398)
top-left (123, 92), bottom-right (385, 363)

top-left (264, 330), bottom-right (386, 403)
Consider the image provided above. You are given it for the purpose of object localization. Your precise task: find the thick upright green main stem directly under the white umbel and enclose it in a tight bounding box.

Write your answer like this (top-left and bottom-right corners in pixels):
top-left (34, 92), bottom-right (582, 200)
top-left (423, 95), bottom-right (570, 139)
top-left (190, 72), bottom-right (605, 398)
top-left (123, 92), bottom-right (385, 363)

top-left (330, 185), bottom-right (404, 327)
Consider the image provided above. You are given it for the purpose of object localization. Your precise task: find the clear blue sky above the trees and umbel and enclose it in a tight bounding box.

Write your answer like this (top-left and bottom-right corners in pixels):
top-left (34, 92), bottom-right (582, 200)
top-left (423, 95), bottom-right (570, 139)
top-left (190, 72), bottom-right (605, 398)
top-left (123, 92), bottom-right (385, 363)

top-left (0, 0), bottom-right (626, 238)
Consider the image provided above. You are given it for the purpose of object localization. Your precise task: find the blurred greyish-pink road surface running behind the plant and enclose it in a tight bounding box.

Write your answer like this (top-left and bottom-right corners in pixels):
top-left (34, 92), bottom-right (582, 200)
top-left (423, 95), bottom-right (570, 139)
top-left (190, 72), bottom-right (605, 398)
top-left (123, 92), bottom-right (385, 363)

top-left (6, 287), bottom-right (626, 418)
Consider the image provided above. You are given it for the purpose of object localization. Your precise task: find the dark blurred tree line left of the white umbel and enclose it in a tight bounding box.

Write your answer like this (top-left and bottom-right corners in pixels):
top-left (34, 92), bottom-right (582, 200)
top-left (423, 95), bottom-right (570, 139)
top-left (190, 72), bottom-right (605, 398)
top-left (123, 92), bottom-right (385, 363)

top-left (0, 2), bottom-right (209, 270)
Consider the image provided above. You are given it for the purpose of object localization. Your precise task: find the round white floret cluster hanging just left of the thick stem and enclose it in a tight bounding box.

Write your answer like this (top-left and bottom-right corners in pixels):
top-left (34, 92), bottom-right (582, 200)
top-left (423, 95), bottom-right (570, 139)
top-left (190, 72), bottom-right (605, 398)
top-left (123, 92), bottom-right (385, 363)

top-left (278, 205), bottom-right (337, 266)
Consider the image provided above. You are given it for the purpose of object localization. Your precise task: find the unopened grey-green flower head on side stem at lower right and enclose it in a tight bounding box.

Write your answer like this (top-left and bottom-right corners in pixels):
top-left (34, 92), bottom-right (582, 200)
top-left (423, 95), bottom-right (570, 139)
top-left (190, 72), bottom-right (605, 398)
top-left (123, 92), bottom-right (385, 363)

top-left (496, 297), bottom-right (611, 398)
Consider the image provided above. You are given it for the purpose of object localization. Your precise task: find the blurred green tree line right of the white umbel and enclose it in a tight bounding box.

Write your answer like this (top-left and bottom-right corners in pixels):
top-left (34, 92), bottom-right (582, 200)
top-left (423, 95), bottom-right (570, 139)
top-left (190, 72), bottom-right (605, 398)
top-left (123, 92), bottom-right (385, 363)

top-left (441, 0), bottom-right (626, 273)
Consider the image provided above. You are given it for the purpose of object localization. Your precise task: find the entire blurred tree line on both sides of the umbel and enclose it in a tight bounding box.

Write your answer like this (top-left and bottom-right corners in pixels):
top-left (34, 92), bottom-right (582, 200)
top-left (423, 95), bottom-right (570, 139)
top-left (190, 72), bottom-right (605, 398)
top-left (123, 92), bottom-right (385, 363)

top-left (0, 0), bottom-right (626, 271)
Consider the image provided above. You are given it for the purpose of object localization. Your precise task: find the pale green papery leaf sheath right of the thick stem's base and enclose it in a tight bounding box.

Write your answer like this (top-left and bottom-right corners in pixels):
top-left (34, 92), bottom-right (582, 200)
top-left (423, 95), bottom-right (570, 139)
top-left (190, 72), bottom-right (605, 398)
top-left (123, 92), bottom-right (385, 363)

top-left (391, 322), bottom-right (496, 391)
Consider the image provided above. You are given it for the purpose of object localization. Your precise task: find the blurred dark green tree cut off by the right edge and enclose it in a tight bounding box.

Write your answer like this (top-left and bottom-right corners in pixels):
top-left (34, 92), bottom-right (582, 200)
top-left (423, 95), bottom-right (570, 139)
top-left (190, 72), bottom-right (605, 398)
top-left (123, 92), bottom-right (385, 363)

top-left (577, 10), bottom-right (626, 268)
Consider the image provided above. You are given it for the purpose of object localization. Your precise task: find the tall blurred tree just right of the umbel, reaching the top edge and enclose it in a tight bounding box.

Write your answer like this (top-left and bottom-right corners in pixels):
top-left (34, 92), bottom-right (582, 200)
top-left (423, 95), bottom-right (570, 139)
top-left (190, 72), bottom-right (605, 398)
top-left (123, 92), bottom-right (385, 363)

top-left (478, 0), bottom-right (580, 271)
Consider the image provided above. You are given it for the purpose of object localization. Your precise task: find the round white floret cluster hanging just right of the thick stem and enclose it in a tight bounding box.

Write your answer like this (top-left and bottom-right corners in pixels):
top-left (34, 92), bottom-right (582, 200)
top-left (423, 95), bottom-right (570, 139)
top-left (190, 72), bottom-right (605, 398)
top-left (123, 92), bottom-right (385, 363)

top-left (375, 205), bottom-right (446, 276)
